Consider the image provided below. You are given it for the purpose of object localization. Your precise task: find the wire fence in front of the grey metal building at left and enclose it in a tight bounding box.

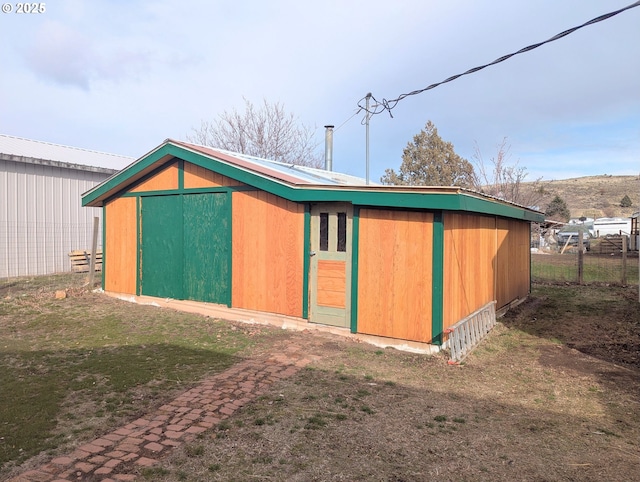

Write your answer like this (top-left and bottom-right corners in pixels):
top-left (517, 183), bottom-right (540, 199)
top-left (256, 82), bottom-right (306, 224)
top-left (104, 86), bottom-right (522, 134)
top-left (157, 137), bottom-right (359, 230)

top-left (0, 222), bottom-right (102, 279)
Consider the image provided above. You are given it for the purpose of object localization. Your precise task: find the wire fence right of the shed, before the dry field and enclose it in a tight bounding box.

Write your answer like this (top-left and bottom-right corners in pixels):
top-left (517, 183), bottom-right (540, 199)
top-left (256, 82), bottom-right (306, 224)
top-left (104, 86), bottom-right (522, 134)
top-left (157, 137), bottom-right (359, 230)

top-left (531, 249), bottom-right (638, 286)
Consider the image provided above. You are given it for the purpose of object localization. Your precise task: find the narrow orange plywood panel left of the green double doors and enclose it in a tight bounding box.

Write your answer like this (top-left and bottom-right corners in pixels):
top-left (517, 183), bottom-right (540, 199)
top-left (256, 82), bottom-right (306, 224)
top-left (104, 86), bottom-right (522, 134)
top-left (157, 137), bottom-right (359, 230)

top-left (104, 197), bottom-right (137, 295)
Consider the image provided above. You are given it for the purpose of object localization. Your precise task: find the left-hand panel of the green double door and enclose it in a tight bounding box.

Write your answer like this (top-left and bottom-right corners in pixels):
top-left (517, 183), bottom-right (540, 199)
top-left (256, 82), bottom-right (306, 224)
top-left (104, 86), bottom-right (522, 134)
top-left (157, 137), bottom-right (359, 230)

top-left (140, 196), bottom-right (184, 300)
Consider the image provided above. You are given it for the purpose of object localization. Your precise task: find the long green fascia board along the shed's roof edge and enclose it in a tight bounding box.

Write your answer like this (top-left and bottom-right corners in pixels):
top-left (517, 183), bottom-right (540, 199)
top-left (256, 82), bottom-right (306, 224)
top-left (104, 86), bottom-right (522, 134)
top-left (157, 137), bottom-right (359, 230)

top-left (82, 142), bottom-right (544, 222)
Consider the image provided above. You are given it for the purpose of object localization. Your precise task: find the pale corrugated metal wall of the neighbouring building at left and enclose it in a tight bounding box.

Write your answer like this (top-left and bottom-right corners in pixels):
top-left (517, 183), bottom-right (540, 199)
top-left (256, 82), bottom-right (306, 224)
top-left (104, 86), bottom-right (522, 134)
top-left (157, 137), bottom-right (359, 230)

top-left (0, 159), bottom-right (108, 278)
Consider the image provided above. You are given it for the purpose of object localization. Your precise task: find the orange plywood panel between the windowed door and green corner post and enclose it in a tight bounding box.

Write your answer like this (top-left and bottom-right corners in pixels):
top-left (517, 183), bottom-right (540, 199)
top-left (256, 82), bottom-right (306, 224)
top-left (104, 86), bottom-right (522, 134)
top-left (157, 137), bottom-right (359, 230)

top-left (358, 209), bottom-right (433, 342)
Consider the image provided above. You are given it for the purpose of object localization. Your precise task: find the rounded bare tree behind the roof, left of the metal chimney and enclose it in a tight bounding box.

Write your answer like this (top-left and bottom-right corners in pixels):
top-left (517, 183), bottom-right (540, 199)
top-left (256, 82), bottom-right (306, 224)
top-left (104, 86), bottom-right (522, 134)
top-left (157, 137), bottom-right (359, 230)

top-left (187, 99), bottom-right (322, 167)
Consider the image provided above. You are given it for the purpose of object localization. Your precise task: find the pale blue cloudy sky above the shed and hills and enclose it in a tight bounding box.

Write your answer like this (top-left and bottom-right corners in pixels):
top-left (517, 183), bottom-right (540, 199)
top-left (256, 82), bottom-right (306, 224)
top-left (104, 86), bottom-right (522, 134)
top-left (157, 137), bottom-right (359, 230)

top-left (0, 0), bottom-right (640, 181)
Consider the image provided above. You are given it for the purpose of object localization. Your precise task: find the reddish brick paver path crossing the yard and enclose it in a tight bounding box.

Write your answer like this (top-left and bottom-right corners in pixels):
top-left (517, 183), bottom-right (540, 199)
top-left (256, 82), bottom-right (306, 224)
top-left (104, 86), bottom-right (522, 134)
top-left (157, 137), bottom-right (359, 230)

top-left (9, 342), bottom-right (318, 482)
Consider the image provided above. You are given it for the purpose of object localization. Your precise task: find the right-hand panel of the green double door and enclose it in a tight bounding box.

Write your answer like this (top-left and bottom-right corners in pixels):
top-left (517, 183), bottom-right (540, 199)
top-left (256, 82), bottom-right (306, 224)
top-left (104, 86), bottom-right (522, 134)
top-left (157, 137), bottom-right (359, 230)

top-left (183, 193), bottom-right (231, 305)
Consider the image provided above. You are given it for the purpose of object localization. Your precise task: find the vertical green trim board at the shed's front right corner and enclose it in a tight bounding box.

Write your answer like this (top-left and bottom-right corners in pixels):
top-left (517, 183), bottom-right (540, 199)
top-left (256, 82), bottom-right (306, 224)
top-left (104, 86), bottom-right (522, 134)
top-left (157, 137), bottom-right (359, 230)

top-left (431, 211), bottom-right (444, 345)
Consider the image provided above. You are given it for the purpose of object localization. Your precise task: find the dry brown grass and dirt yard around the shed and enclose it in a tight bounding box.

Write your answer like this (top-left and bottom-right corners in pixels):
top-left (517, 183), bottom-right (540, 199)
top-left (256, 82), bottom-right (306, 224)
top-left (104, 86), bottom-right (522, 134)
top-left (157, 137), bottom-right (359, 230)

top-left (0, 281), bottom-right (640, 482)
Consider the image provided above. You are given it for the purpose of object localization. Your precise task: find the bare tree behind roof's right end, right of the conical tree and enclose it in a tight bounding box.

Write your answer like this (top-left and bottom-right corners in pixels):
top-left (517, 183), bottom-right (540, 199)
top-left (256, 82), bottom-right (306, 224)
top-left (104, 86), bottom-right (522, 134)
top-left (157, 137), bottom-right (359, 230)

top-left (473, 137), bottom-right (545, 208)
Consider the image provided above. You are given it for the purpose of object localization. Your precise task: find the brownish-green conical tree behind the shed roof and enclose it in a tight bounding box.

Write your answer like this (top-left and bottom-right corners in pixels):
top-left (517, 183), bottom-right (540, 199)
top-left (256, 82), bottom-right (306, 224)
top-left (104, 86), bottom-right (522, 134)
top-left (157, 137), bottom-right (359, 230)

top-left (380, 121), bottom-right (476, 188)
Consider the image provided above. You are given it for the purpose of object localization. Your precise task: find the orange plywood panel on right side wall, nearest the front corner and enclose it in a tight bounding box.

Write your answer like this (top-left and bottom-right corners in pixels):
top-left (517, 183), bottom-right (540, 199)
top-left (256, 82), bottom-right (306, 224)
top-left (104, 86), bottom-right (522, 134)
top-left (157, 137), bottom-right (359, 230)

top-left (443, 212), bottom-right (496, 328)
